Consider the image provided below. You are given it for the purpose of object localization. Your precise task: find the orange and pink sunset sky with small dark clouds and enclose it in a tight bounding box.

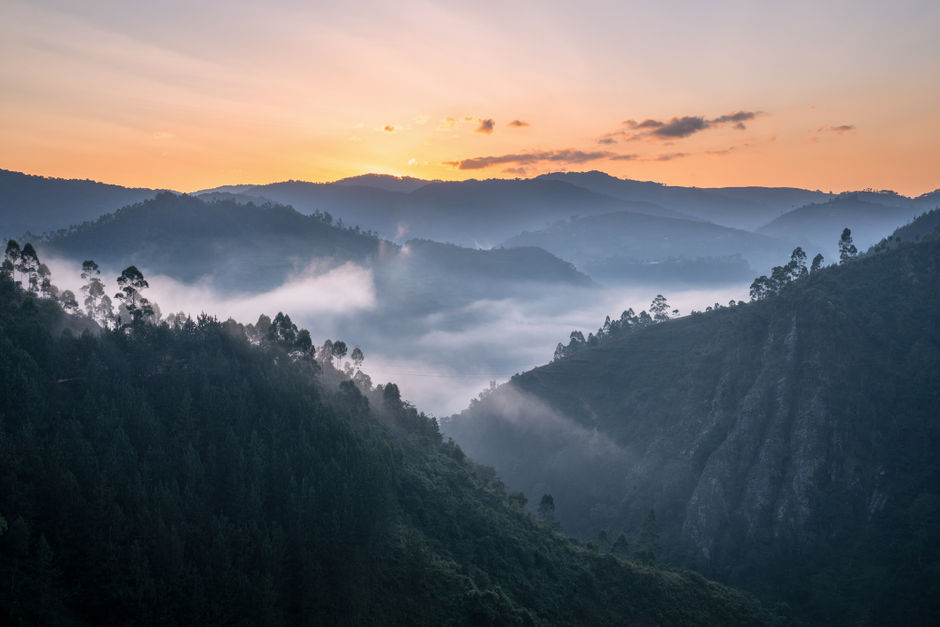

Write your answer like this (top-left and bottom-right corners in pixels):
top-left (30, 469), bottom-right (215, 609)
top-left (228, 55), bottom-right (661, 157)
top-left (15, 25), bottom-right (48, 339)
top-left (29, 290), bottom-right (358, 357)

top-left (0, 0), bottom-right (940, 195)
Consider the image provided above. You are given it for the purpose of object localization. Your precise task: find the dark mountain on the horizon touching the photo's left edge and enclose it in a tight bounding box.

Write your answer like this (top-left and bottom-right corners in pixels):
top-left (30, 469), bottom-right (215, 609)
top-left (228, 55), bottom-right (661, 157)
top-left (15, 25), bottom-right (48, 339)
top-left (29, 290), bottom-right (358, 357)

top-left (0, 170), bottom-right (158, 237)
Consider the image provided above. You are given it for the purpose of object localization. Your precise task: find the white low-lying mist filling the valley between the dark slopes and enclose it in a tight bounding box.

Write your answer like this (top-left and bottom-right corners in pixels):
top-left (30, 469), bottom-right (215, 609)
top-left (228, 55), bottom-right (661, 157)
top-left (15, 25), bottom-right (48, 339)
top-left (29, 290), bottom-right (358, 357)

top-left (43, 250), bottom-right (748, 416)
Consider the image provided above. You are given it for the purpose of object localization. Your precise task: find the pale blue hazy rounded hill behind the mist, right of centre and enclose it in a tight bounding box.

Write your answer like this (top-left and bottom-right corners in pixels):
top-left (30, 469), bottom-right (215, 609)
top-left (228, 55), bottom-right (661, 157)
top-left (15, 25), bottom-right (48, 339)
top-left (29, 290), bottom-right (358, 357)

top-left (503, 212), bottom-right (793, 283)
